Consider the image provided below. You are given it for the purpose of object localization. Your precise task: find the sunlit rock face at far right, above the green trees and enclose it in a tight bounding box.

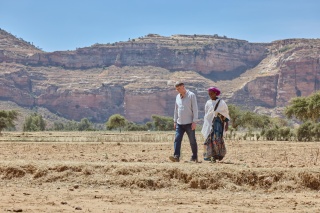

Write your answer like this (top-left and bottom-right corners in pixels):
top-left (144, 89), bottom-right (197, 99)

top-left (231, 39), bottom-right (320, 109)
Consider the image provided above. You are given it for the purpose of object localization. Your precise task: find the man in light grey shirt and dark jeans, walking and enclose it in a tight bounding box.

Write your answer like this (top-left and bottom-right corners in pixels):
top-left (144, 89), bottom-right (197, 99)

top-left (169, 82), bottom-right (198, 162)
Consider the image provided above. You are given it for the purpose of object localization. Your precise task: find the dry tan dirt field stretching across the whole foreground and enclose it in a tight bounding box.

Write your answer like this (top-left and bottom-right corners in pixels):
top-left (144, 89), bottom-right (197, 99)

top-left (0, 132), bottom-right (320, 212)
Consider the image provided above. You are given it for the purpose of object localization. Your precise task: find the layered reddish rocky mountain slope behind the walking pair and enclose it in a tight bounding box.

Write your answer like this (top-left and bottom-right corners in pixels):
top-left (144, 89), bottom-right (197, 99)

top-left (0, 30), bottom-right (320, 125)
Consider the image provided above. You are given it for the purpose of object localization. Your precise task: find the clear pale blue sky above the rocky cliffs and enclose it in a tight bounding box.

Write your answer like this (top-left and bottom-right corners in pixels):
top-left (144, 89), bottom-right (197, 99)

top-left (0, 0), bottom-right (320, 52)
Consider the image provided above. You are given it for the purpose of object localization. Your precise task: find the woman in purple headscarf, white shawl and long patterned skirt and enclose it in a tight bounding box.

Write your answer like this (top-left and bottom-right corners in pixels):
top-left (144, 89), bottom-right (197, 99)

top-left (201, 87), bottom-right (230, 162)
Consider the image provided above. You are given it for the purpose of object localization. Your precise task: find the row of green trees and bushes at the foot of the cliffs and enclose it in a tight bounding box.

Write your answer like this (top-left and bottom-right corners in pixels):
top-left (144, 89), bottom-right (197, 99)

top-left (0, 92), bottom-right (320, 141)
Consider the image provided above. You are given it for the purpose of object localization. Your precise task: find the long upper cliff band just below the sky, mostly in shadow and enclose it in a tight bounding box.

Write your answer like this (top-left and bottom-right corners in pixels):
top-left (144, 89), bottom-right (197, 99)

top-left (0, 35), bottom-right (266, 74)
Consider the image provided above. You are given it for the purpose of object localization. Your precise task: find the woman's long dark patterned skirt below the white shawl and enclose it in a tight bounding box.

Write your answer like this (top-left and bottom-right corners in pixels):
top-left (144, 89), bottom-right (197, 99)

top-left (203, 116), bottom-right (227, 162)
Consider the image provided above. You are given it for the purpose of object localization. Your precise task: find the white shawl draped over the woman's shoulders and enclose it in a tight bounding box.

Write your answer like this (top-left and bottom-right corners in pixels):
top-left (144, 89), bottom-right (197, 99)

top-left (201, 99), bottom-right (230, 138)
